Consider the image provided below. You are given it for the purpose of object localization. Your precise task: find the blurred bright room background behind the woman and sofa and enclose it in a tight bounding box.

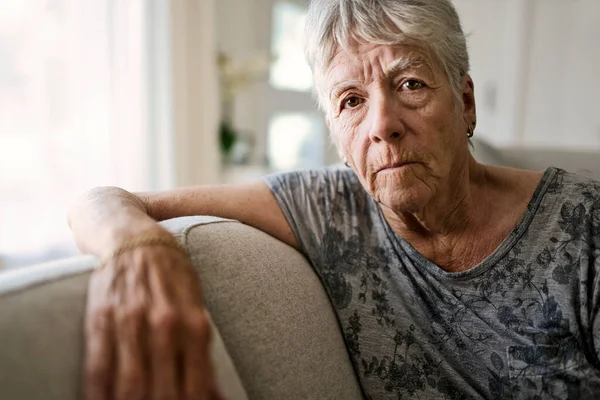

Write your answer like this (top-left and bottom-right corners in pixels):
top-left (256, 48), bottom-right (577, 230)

top-left (0, 0), bottom-right (600, 269)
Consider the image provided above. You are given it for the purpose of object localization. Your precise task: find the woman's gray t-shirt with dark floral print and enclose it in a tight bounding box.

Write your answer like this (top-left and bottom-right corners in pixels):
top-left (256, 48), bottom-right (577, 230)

top-left (266, 168), bottom-right (600, 399)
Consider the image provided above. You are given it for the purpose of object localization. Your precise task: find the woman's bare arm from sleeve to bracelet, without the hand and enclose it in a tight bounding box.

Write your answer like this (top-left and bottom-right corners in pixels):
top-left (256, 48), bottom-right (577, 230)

top-left (68, 181), bottom-right (298, 256)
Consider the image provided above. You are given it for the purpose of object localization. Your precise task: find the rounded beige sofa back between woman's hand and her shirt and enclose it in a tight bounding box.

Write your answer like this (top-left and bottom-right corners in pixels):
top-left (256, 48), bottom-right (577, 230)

top-left (165, 217), bottom-right (362, 400)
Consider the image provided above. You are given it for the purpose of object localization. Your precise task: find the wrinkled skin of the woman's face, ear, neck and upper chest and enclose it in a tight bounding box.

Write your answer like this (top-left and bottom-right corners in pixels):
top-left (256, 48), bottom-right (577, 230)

top-left (317, 43), bottom-right (541, 272)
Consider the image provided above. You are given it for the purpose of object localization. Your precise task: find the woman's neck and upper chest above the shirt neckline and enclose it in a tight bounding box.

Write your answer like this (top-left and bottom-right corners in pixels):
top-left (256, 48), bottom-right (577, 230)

top-left (382, 160), bottom-right (543, 272)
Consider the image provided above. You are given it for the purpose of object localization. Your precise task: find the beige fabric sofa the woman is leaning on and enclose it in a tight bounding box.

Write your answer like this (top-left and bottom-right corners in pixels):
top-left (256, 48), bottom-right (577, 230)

top-left (0, 141), bottom-right (600, 400)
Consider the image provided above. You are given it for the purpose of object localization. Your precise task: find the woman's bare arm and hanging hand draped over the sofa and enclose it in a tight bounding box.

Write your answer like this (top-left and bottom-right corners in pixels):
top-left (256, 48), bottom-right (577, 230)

top-left (68, 182), bottom-right (297, 400)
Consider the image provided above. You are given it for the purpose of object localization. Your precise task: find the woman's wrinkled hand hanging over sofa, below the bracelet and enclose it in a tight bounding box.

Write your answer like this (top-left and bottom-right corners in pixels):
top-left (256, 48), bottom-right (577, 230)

top-left (83, 245), bottom-right (222, 400)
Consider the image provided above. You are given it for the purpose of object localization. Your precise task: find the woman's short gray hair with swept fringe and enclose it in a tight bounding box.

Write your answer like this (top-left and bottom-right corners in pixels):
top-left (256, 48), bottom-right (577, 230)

top-left (304, 0), bottom-right (469, 109)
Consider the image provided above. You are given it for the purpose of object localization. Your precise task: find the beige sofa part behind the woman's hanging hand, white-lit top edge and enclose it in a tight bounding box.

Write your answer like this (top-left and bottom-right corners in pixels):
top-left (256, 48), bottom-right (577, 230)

top-left (0, 221), bottom-right (248, 400)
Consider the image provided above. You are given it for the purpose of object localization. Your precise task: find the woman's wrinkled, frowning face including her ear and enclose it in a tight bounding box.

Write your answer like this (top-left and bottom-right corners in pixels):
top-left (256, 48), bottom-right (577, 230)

top-left (321, 45), bottom-right (475, 212)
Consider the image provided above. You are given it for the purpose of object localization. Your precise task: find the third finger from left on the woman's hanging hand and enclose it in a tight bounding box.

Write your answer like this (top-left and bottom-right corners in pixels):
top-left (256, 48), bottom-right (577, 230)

top-left (149, 307), bottom-right (180, 400)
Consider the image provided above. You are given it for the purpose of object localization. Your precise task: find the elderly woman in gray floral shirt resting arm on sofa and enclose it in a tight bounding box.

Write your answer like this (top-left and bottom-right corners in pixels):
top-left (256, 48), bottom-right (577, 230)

top-left (70, 0), bottom-right (600, 399)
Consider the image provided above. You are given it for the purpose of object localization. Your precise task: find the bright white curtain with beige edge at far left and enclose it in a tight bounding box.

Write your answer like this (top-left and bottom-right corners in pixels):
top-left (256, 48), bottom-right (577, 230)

top-left (0, 0), bottom-right (220, 270)
